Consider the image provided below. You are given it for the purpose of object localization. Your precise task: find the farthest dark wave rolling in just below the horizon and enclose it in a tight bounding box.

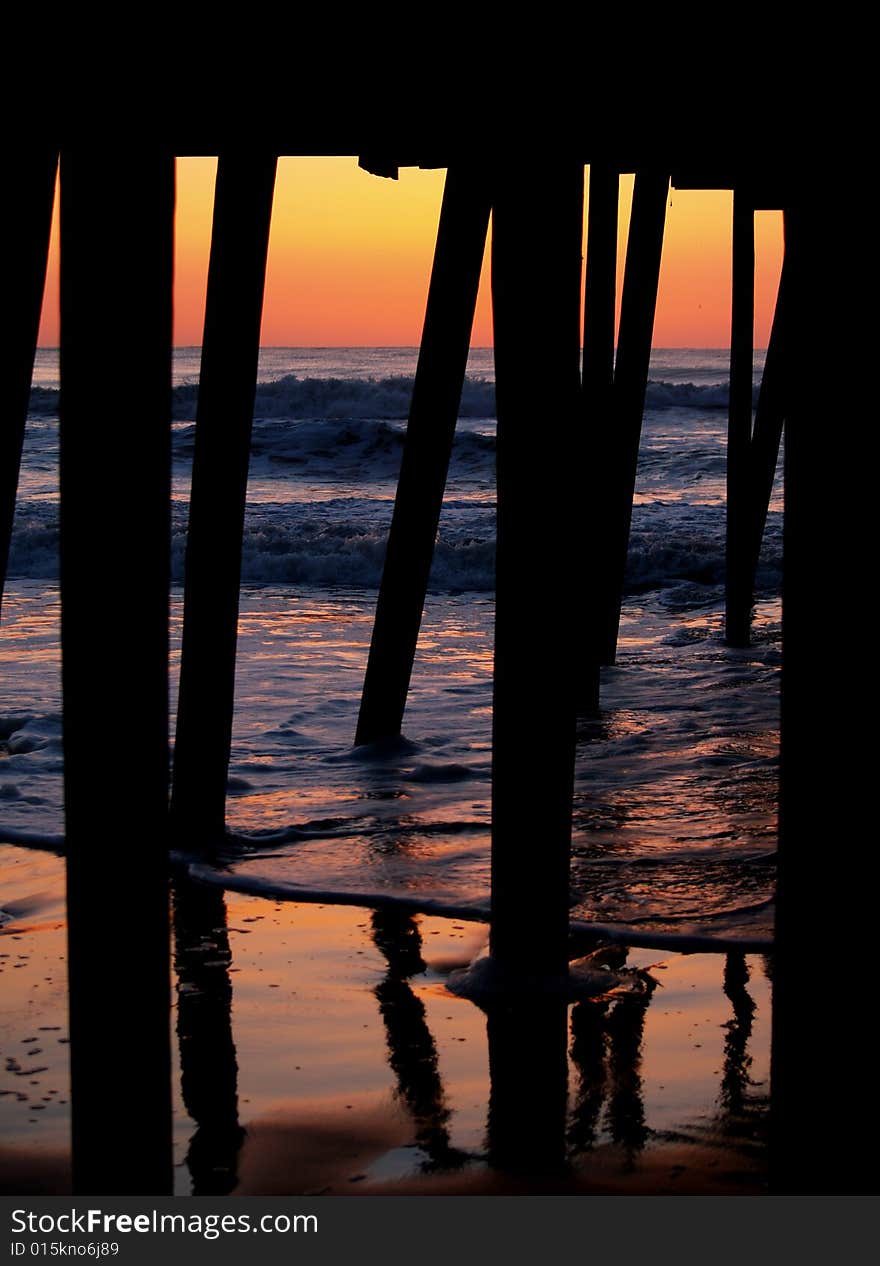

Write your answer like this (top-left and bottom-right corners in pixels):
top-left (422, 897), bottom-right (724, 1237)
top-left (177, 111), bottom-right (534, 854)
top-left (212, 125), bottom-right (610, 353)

top-left (30, 373), bottom-right (744, 422)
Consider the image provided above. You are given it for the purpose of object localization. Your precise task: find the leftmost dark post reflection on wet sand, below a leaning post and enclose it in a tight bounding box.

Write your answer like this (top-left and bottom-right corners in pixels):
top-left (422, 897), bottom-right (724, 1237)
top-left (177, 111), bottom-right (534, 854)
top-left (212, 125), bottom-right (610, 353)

top-left (173, 872), bottom-right (244, 1195)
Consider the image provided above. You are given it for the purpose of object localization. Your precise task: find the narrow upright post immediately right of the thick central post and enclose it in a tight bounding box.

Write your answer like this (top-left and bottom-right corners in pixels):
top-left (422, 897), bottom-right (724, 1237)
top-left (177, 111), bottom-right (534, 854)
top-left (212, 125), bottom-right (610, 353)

top-left (577, 163), bottom-right (620, 715)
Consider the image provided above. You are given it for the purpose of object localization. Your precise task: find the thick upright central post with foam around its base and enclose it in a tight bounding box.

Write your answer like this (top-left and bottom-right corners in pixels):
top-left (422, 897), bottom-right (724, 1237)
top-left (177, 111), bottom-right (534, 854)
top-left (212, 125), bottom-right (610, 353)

top-left (491, 162), bottom-right (584, 981)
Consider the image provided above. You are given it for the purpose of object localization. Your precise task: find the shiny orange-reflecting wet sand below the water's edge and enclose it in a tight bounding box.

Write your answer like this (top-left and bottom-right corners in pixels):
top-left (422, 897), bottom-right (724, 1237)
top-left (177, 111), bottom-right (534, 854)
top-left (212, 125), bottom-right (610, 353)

top-left (0, 848), bottom-right (770, 1195)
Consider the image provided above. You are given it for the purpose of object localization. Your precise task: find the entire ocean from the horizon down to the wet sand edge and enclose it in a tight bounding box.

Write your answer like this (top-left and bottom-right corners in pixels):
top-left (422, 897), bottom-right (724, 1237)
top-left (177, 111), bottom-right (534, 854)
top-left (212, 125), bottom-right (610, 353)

top-left (0, 348), bottom-right (783, 937)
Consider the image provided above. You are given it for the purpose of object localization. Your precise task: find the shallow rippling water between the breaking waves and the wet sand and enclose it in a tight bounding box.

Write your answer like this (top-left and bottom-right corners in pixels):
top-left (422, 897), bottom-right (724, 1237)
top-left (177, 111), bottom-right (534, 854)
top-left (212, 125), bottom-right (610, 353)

top-left (0, 585), bottom-right (779, 936)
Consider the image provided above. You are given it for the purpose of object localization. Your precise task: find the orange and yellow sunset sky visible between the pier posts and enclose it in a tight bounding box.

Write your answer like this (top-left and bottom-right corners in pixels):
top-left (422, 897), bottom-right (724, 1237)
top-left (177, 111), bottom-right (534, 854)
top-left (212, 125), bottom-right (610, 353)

top-left (39, 157), bottom-right (783, 347)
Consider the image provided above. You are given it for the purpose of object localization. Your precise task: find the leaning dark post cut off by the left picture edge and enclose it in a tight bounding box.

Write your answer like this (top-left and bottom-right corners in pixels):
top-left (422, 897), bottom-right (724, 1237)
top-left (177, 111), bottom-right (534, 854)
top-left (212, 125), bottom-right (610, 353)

top-left (0, 148), bottom-right (58, 617)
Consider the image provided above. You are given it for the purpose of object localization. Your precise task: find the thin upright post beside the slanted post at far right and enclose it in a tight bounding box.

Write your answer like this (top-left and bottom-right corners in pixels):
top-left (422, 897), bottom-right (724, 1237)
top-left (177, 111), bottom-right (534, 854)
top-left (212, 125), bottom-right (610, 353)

top-left (724, 189), bottom-right (755, 646)
